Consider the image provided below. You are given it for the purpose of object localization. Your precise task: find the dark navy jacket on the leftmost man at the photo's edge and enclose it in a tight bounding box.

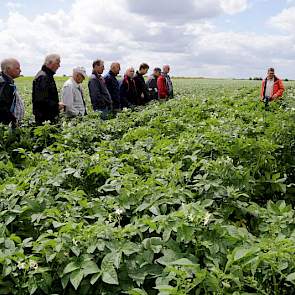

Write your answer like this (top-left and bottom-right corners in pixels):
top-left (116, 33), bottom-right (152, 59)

top-left (0, 73), bottom-right (16, 125)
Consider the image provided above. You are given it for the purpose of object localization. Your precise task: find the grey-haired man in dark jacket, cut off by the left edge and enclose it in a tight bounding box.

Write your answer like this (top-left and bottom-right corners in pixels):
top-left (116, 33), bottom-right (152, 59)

top-left (0, 58), bottom-right (21, 125)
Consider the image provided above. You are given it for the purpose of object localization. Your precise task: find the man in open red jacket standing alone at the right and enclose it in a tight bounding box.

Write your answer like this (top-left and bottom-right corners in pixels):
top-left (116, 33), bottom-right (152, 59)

top-left (260, 68), bottom-right (285, 102)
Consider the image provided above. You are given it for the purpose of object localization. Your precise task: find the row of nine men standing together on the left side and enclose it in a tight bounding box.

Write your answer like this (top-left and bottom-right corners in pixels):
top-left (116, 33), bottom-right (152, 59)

top-left (0, 54), bottom-right (173, 126)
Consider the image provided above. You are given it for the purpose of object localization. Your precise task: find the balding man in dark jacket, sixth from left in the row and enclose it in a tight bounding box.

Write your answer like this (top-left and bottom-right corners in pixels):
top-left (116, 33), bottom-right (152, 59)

top-left (120, 67), bottom-right (138, 108)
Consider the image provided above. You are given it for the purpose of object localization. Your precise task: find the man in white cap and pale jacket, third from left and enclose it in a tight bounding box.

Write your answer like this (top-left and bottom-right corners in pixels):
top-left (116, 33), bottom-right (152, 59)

top-left (62, 67), bottom-right (87, 117)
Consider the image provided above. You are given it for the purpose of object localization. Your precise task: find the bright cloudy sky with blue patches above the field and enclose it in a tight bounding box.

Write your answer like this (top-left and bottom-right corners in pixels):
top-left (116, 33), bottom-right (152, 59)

top-left (0, 0), bottom-right (295, 79)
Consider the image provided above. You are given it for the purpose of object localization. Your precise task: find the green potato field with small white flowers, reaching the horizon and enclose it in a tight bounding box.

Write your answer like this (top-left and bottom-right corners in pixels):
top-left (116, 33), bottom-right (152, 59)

top-left (0, 78), bottom-right (295, 295)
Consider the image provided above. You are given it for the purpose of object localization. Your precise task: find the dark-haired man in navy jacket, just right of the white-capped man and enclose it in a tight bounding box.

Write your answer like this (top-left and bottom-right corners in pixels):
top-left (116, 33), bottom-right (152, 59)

top-left (88, 59), bottom-right (113, 119)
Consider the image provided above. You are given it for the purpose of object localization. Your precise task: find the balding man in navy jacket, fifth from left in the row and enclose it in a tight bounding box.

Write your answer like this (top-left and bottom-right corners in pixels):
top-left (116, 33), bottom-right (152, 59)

top-left (104, 62), bottom-right (121, 112)
